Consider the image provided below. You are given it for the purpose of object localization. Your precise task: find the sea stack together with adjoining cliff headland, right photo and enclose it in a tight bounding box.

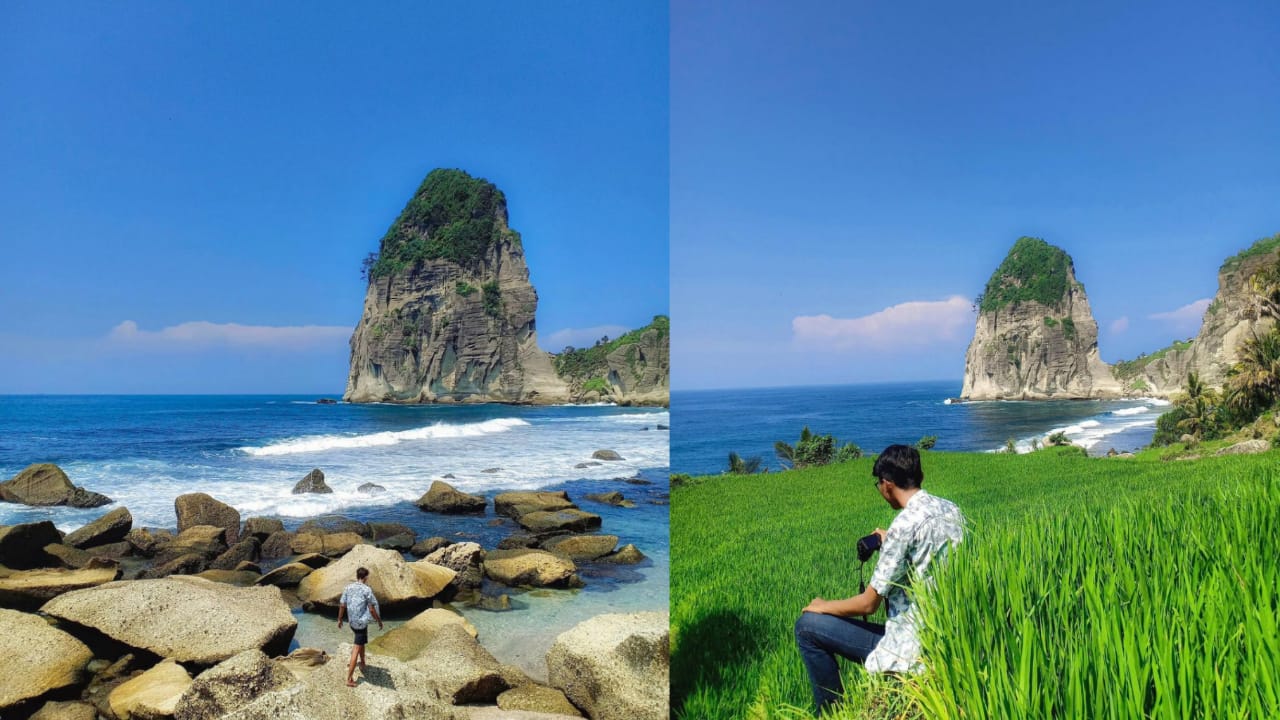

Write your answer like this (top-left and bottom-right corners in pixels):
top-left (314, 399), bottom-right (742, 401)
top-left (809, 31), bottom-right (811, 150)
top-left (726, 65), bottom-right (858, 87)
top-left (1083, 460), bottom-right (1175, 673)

top-left (957, 236), bottom-right (1280, 401)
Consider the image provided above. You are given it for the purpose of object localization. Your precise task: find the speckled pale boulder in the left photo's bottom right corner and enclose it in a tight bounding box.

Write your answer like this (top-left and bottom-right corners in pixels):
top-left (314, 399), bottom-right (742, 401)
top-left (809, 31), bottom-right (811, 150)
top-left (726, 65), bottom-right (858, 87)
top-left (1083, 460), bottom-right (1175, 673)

top-left (547, 612), bottom-right (671, 720)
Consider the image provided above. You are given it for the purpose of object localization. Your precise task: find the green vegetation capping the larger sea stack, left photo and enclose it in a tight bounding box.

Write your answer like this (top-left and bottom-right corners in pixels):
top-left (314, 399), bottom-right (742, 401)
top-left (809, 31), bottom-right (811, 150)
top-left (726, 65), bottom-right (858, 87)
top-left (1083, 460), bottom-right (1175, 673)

top-left (365, 169), bottom-right (520, 281)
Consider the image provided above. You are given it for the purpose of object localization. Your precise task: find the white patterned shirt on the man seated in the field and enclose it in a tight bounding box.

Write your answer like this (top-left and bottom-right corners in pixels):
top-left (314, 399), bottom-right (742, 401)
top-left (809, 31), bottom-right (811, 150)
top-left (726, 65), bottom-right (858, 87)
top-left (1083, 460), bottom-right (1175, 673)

top-left (867, 489), bottom-right (964, 673)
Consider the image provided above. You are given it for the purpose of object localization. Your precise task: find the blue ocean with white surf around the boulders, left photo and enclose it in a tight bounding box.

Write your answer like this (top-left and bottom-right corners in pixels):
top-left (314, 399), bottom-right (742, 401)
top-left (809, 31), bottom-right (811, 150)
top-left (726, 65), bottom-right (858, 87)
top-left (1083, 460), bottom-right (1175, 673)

top-left (0, 396), bottom-right (669, 676)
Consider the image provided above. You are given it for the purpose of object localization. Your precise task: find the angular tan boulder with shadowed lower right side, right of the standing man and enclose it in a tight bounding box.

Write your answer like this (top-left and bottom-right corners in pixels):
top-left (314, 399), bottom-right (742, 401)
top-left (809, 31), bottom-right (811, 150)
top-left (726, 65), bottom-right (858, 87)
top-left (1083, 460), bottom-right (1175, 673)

top-left (408, 624), bottom-right (508, 705)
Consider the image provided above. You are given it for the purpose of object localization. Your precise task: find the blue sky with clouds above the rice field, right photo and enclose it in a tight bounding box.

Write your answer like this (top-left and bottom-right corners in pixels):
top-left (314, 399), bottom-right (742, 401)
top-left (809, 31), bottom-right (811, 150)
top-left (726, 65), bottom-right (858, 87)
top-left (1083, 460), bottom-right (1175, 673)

top-left (671, 0), bottom-right (1280, 391)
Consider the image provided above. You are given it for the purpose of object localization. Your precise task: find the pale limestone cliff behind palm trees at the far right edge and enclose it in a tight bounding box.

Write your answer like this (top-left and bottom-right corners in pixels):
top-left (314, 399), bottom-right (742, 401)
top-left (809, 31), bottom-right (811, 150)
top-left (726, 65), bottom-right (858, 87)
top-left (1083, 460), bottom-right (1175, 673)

top-left (1115, 236), bottom-right (1280, 397)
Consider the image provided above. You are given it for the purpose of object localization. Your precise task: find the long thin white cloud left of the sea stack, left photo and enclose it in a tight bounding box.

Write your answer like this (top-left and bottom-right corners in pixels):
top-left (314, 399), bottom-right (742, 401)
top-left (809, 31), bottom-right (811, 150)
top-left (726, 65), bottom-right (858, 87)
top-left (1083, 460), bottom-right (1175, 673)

top-left (108, 320), bottom-right (352, 350)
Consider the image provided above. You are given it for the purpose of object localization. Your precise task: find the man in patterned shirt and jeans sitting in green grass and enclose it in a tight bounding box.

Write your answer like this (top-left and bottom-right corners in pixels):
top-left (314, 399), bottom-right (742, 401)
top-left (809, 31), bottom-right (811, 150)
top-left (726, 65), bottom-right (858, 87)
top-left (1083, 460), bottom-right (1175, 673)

top-left (796, 445), bottom-right (964, 714)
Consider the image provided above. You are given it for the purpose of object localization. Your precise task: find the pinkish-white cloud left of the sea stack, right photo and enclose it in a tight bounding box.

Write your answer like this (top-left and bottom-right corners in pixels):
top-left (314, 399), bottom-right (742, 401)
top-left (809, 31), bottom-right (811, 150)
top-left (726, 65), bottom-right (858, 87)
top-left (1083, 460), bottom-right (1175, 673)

top-left (791, 295), bottom-right (974, 348)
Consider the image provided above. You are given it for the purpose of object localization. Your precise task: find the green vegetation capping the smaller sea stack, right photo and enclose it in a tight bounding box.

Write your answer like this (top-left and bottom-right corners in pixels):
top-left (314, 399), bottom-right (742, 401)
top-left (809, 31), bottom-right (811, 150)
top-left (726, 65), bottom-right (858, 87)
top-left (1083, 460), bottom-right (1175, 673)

top-left (978, 237), bottom-right (1071, 313)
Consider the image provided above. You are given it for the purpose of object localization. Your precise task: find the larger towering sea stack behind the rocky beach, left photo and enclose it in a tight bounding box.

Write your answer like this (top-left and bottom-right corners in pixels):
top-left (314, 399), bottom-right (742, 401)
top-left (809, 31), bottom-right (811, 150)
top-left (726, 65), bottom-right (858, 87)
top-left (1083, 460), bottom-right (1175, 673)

top-left (343, 169), bottom-right (570, 402)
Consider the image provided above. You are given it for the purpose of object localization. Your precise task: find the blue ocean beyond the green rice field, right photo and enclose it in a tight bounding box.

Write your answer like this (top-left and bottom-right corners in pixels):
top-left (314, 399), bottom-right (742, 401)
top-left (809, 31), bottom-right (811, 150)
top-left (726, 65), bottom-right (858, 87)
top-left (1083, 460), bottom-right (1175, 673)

top-left (671, 380), bottom-right (1169, 475)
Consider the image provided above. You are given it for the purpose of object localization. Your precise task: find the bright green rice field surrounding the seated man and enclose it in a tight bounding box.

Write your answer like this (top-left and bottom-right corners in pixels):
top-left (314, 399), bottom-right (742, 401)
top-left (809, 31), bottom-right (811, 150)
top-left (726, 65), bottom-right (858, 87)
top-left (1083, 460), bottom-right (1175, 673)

top-left (671, 448), bottom-right (1280, 720)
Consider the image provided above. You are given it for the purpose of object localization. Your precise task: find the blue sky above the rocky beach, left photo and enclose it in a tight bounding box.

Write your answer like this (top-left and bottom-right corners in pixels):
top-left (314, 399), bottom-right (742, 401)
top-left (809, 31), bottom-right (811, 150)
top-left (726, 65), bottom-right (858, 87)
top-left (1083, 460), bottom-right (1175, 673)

top-left (0, 1), bottom-right (669, 393)
